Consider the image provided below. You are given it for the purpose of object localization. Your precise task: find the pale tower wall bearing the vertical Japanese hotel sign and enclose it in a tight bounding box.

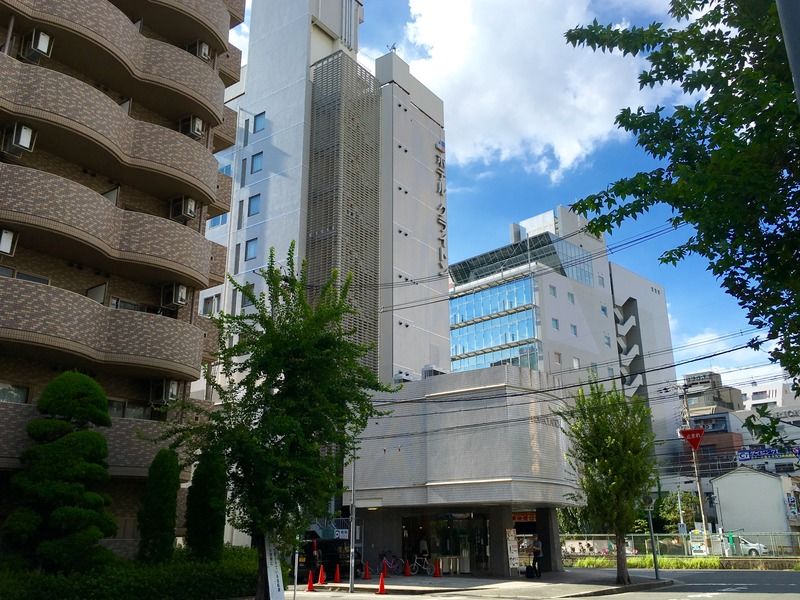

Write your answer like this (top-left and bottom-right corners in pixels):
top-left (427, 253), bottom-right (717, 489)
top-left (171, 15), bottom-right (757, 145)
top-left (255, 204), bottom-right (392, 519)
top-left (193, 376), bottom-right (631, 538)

top-left (376, 53), bottom-right (450, 381)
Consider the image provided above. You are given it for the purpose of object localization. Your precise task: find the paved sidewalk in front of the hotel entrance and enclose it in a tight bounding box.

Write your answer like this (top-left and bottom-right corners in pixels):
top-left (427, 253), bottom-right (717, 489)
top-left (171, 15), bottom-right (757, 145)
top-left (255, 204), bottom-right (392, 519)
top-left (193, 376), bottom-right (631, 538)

top-left (286, 569), bottom-right (672, 600)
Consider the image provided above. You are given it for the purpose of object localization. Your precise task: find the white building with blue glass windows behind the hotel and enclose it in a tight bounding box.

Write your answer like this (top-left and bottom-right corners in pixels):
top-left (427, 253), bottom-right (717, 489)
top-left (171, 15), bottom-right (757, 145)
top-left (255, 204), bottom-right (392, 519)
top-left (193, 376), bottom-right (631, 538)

top-left (450, 206), bottom-right (680, 451)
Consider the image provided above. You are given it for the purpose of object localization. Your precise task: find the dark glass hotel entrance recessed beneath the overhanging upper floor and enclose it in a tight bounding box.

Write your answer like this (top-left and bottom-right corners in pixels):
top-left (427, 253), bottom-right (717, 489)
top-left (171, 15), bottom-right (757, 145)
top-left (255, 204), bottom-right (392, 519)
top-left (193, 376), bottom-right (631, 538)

top-left (402, 512), bottom-right (489, 575)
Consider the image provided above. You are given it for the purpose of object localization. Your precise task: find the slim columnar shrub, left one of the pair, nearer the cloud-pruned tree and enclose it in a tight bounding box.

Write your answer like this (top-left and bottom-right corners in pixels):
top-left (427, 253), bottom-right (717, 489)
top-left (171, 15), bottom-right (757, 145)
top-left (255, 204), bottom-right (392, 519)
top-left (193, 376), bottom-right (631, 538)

top-left (138, 448), bottom-right (181, 563)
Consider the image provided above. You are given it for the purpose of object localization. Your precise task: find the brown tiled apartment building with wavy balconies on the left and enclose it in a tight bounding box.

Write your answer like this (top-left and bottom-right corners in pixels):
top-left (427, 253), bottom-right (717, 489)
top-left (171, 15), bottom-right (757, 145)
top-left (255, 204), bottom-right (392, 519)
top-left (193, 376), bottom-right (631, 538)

top-left (0, 0), bottom-right (245, 551)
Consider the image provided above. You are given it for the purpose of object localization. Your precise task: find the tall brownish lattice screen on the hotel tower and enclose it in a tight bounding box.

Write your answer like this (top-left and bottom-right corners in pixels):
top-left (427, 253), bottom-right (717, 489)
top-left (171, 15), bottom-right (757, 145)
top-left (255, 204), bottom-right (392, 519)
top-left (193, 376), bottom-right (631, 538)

top-left (306, 52), bottom-right (380, 372)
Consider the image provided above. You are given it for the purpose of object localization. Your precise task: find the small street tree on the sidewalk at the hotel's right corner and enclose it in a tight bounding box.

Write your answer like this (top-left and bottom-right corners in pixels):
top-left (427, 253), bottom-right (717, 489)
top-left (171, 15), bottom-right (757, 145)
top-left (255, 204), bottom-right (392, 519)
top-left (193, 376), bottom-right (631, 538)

top-left (557, 382), bottom-right (656, 585)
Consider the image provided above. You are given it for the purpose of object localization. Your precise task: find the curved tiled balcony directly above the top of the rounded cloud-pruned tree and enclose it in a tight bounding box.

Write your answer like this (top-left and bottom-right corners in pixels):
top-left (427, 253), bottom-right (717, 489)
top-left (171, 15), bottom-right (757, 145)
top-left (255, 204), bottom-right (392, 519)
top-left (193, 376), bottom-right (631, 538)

top-left (0, 278), bottom-right (204, 380)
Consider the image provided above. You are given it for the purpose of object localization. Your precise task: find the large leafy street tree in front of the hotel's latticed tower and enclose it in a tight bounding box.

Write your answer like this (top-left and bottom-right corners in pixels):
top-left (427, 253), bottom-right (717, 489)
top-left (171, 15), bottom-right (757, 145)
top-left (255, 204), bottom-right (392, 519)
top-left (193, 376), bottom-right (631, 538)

top-left (169, 245), bottom-right (390, 600)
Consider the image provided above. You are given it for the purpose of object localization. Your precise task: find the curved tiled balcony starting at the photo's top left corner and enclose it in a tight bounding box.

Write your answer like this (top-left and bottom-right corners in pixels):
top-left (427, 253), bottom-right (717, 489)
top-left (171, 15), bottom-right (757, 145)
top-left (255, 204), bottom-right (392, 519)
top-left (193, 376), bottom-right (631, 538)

top-left (0, 0), bottom-right (225, 125)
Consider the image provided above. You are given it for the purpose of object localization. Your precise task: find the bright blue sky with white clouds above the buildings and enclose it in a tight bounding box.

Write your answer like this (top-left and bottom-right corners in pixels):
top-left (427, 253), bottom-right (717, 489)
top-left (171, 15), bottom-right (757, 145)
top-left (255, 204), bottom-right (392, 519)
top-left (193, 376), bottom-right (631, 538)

top-left (232, 0), bottom-right (780, 389)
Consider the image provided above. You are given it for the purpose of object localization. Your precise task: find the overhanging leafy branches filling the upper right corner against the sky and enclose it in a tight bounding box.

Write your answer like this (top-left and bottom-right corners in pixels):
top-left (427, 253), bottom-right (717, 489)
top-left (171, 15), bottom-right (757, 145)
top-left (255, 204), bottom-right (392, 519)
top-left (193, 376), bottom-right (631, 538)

top-left (566, 0), bottom-right (800, 394)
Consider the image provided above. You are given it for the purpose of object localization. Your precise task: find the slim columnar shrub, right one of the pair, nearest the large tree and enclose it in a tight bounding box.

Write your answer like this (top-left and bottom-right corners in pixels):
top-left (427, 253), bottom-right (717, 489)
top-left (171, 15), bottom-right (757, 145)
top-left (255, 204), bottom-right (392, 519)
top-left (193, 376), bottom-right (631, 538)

top-left (186, 451), bottom-right (228, 561)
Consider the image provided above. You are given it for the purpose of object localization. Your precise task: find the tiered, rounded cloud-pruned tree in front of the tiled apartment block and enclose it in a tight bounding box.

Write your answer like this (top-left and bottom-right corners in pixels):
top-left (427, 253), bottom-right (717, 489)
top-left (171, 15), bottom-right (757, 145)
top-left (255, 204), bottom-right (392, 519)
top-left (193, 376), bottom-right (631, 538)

top-left (3, 372), bottom-right (117, 573)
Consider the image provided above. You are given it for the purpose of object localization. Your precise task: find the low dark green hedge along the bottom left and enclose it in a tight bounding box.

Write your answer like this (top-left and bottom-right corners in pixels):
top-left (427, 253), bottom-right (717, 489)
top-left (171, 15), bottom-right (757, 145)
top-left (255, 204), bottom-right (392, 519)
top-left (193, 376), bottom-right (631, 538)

top-left (0, 547), bottom-right (258, 600)
